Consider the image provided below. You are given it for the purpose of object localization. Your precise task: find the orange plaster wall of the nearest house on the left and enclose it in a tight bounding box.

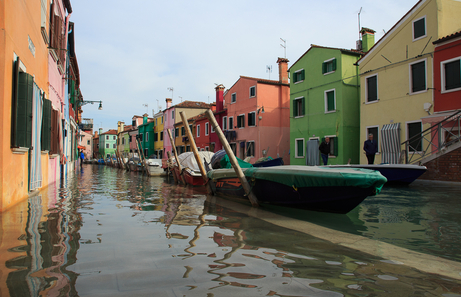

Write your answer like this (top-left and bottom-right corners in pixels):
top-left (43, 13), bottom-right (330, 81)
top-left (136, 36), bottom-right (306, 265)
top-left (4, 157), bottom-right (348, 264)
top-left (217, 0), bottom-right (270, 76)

top-left (0, 1), bottom-right (49, 211)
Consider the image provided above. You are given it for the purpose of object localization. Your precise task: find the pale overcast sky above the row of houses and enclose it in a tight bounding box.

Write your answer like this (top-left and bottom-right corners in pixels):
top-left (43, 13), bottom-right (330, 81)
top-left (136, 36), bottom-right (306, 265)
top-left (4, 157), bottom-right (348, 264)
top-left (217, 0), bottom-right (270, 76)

top-left (70, 0), bottom-right (417, 130)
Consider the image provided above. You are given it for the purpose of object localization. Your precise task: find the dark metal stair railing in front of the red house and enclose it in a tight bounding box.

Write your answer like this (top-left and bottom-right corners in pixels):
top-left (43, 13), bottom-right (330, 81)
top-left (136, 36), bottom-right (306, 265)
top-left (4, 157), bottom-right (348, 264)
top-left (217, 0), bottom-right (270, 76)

top-left (402, 110), bottom-right (461, 164)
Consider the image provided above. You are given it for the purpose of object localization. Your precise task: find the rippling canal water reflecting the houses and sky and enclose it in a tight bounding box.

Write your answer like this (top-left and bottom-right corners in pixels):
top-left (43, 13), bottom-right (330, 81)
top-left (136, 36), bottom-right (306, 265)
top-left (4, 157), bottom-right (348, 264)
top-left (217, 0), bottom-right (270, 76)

top-left (0, 165), bottom-right (461, 296)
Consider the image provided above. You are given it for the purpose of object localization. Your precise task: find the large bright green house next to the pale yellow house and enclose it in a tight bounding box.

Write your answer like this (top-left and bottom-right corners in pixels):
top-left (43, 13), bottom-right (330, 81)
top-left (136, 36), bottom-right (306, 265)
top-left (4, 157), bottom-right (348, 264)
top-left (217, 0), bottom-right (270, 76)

top-left (289, 45), bottom-right (363, 165)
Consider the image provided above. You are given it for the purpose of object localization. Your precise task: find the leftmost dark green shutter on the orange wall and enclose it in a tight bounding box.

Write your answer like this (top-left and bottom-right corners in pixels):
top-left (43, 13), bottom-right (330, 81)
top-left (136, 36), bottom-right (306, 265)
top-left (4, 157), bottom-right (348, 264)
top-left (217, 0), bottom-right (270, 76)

top-left (13, 72), bottom-right (34, 148)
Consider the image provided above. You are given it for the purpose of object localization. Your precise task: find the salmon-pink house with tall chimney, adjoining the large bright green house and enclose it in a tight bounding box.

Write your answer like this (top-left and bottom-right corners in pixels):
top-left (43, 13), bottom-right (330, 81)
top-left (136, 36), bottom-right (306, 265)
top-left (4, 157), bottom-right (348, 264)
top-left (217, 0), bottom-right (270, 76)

top-left (222, 58), bottom-right (290, 165)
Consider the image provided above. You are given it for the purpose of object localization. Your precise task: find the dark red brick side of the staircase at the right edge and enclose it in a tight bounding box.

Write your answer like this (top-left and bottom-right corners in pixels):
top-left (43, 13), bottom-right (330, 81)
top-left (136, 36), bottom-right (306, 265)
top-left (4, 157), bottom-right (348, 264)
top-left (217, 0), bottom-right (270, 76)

top-left (420, 147), bottom-right (461, 182)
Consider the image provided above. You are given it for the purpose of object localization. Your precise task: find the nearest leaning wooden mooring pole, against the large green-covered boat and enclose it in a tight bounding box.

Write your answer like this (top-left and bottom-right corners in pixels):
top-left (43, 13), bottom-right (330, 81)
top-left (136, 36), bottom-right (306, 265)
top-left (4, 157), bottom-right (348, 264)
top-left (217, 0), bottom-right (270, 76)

top-left (206, 109), bottom-right (259, 207)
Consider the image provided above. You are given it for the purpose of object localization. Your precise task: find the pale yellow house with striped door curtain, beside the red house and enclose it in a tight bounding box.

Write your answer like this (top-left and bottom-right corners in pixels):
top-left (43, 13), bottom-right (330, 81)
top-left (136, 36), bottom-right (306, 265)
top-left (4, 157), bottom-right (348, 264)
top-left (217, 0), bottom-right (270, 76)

top-left (358, 0), bottom-right (461, 164)
